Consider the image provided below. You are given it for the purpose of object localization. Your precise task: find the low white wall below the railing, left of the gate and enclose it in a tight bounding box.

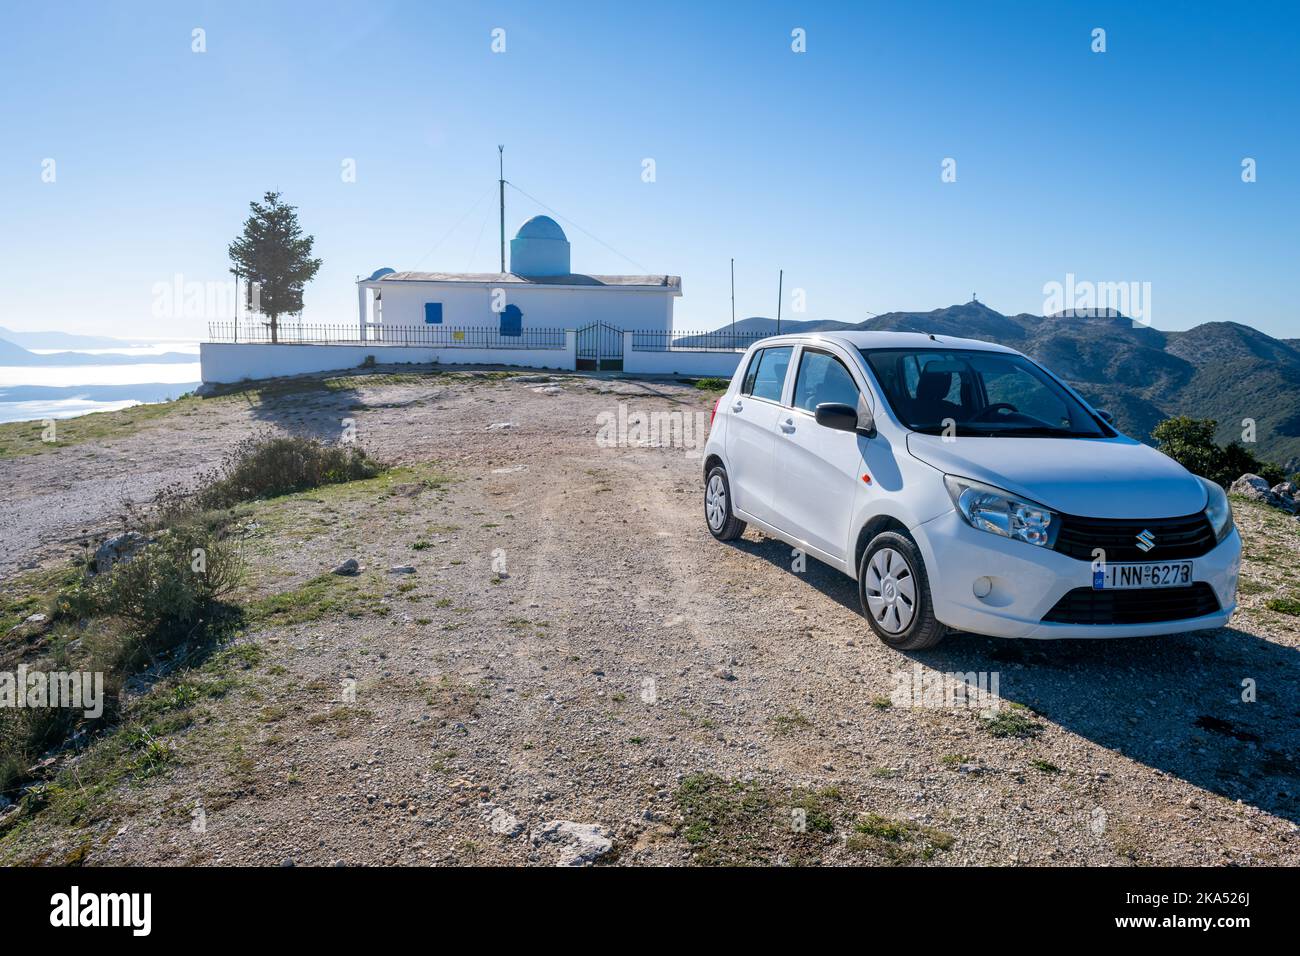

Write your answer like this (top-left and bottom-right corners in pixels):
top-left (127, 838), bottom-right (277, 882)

top-left (199, 332), bottom-right (577, 385)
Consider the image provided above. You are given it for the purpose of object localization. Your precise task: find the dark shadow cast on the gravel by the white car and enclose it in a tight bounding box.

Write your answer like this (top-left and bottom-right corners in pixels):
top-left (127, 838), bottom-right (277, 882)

top-left (733, 537), bottom-right (1300, 823)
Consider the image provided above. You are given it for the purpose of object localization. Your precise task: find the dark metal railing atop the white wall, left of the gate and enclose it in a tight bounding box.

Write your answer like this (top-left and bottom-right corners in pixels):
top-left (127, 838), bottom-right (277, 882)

top-left (208, 321), bottom-right (566, 349)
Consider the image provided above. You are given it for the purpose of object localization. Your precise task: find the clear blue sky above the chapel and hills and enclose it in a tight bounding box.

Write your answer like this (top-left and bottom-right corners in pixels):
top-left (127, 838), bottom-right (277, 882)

top-left (0, 0), bottom-right (1300, 337)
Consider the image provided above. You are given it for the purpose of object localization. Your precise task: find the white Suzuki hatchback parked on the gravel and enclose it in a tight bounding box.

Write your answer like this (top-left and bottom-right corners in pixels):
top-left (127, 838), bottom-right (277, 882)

top-left (705, 332), bottom-right (1242, 650)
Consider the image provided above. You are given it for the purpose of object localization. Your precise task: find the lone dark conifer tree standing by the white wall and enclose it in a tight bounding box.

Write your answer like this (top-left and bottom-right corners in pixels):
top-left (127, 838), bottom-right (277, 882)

top-left (229, 193), bottom-right (321, 342)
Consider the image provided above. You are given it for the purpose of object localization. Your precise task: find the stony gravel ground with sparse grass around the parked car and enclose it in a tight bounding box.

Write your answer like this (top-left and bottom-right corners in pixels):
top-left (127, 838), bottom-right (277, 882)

top-left (0, 375), bottom-right (1300, 865)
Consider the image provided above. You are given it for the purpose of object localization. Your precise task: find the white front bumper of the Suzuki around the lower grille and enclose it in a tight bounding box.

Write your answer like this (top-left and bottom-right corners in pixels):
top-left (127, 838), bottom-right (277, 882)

top-left (913, 510), bottom-right (1242, 639)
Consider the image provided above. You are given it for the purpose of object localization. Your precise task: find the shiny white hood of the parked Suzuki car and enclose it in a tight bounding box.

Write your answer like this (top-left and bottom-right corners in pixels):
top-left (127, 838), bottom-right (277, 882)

top-left (907, 432), bottom-right (1205, 519)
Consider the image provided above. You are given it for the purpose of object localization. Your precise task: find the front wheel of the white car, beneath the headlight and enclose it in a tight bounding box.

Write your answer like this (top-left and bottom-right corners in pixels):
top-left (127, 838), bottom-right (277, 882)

top-left (858, 531), bottom-right (948, 650)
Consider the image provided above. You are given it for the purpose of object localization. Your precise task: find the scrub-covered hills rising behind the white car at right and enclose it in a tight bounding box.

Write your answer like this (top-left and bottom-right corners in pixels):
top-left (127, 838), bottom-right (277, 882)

top-left (707, 302), bottom-right (1300, 468)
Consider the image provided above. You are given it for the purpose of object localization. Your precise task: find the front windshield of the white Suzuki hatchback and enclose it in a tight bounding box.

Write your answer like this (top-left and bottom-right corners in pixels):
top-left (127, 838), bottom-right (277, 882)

top-left (862, 349), bottom-right (1109, 438)
